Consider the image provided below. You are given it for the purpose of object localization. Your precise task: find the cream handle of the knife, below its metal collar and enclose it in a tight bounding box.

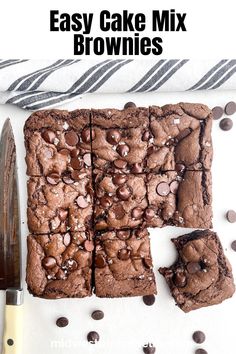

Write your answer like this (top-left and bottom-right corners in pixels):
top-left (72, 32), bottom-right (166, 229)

top-left (2, 305), bottom-right (23, 354)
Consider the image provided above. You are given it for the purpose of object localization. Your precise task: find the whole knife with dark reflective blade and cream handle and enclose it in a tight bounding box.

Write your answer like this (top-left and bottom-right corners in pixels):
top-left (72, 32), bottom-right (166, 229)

top-left (0, 119), bottom-right (23, 354)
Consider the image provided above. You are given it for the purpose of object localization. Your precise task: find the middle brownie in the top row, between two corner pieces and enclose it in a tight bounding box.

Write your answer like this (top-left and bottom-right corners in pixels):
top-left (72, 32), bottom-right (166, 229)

top-left (91, 107), bottom-right (150, 174)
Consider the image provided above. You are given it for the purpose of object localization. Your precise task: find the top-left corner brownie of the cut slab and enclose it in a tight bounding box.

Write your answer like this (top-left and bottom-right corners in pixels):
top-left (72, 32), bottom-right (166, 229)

top-left (24, 109), bottom-right (91, 180)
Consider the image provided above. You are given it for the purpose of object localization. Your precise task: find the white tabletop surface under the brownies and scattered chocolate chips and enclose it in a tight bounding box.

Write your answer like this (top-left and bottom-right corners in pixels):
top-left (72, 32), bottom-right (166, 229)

top-left (0, 92), bottom-right (236, 354)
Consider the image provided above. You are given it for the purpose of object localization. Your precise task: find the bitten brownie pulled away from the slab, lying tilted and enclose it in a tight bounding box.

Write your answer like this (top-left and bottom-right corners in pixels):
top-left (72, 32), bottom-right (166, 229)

top-left (159, 230), bottom-right (235, 312)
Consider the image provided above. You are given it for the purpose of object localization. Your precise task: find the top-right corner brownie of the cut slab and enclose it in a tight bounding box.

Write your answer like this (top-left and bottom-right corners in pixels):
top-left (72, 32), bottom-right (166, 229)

top-left (147, 103), bottom-right (212, 172)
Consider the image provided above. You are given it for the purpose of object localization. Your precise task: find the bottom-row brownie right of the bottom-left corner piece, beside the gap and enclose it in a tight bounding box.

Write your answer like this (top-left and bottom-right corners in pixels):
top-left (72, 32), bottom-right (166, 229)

top-left (95, 229), bottom-right (156, 297)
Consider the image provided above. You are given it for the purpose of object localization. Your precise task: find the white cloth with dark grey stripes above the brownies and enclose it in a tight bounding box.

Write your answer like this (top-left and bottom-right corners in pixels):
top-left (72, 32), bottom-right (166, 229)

top-left (0, 59), bottom-right (236, 110)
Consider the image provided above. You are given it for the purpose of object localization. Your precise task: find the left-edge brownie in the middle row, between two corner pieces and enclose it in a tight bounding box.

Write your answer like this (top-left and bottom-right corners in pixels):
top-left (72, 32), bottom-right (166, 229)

top-left (27, 175), bottom-right (93, 234)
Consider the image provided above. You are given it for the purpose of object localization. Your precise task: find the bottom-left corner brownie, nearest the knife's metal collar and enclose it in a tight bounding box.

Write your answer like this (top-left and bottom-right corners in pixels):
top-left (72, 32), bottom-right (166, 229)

top-left (26, 232), bottom-right (94, 299)
